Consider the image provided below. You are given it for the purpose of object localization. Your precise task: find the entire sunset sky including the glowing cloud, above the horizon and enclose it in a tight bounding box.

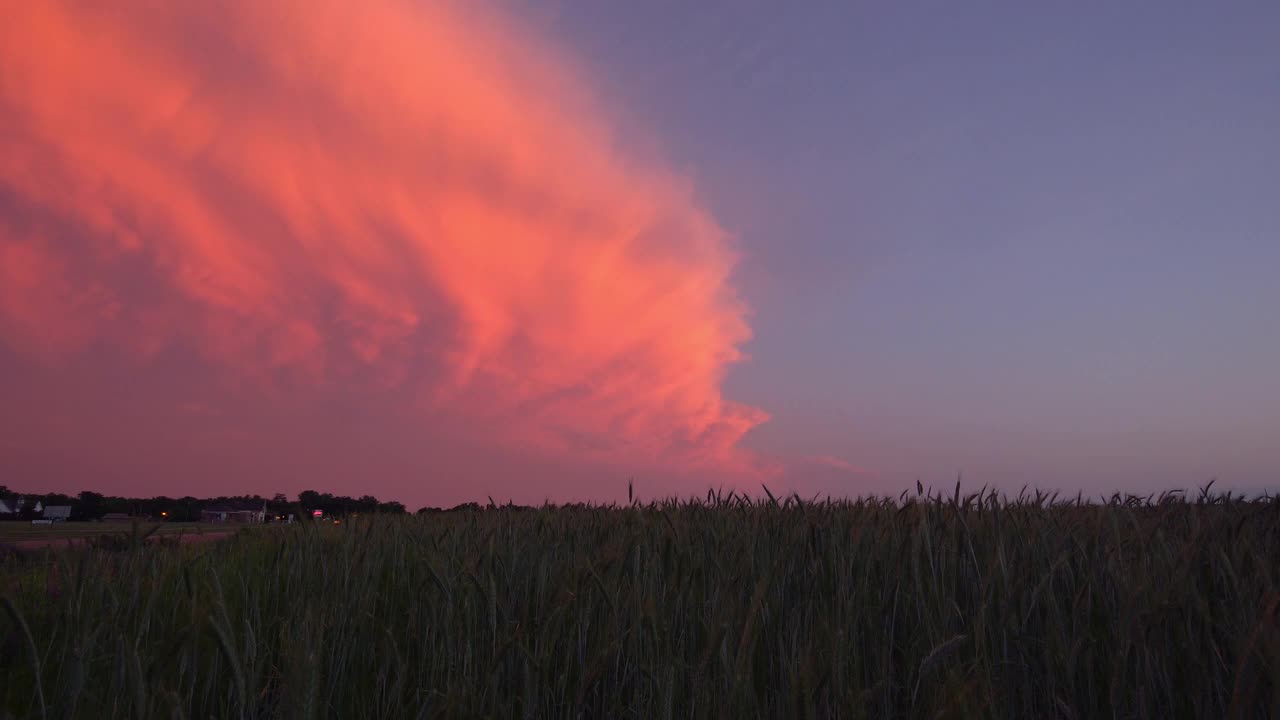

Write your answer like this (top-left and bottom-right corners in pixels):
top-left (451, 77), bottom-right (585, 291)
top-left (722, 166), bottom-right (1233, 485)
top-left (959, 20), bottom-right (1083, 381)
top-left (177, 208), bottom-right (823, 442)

top-left (0, 0), bottom-right (1280, 506)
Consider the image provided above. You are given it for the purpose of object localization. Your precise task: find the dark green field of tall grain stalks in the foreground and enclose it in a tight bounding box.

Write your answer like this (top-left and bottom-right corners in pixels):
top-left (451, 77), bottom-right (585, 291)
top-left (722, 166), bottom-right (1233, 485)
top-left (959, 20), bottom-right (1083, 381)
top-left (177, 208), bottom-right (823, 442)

top-left (0, 496), bottom-right (1280, 719)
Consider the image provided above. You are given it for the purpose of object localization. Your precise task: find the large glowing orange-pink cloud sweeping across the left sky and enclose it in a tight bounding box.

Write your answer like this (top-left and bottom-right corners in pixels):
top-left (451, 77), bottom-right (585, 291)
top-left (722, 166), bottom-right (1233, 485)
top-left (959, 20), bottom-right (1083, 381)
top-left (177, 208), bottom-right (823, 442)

top-left (0, 0), bottom-right (765, 469)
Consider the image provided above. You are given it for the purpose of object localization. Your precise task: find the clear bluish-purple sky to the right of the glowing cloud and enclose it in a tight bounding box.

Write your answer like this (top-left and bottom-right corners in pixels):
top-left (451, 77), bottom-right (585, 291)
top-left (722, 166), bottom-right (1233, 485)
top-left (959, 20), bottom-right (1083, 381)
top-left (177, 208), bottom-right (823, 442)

top-left (512, 1), bottom-right (1280, 492)
